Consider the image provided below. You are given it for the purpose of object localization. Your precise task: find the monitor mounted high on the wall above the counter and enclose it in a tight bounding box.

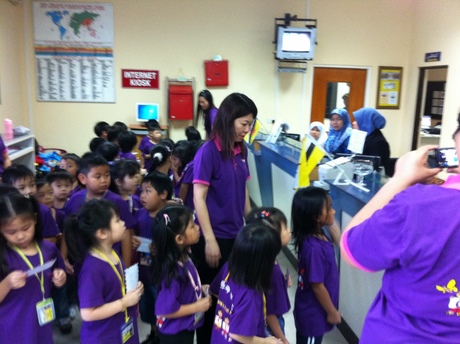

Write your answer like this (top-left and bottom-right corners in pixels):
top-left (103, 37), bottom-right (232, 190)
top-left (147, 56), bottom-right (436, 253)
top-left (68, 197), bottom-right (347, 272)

top-left (276, 26), bottom-right (316, 60)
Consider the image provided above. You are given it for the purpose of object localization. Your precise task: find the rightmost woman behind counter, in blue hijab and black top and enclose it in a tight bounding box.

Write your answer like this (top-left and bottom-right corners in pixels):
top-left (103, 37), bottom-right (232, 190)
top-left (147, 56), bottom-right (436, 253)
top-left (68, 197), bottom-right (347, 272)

top-left (353, 108), bottom-right (390, 172)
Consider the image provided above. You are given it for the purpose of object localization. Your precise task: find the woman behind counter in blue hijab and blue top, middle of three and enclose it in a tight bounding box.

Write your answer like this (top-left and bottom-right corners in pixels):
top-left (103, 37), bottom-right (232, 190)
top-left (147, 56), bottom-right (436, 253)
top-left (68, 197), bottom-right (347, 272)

top-left (324, 109), bottom-right (351, 154)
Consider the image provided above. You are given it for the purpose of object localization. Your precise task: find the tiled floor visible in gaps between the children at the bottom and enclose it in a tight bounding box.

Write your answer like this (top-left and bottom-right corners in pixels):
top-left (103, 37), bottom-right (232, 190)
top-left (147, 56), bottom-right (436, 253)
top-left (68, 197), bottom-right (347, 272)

top-left (54, 253), bottom-right (347, 344)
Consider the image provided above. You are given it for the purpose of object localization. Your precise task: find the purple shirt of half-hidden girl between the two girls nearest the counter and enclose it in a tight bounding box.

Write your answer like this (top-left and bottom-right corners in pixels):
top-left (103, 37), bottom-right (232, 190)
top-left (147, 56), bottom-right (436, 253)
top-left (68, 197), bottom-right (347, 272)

top-left (265, 263), bottom-right (291, 317)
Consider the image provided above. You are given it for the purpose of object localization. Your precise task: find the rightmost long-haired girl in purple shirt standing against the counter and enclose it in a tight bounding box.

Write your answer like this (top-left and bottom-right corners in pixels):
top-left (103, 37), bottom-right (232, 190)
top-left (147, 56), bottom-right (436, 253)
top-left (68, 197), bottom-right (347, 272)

top-left (291, 186), bottom-right (341, 344)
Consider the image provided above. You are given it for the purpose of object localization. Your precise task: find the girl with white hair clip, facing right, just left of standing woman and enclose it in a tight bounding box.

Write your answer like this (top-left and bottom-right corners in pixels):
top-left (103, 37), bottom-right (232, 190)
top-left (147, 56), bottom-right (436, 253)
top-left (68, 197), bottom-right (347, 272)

top-left (152, 205), bottom-right (212, 344)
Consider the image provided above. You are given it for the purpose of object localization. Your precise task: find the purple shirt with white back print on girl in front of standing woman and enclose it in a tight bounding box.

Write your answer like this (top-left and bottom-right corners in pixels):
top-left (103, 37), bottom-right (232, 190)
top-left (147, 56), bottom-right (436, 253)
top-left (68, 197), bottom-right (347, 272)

top-left (210, 263), bottom-right (266, 344)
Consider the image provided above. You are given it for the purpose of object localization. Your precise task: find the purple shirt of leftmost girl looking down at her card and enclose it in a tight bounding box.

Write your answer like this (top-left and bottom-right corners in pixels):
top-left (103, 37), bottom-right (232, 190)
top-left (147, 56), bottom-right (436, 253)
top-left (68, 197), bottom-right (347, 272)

top-left (0, 240), bottom-right (65, 344)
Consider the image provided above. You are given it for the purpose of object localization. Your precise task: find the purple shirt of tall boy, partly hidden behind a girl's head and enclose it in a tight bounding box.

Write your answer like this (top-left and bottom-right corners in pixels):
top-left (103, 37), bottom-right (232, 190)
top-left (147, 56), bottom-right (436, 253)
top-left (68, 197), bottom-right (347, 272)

top-left (65, 189), bottom-right (136, 253)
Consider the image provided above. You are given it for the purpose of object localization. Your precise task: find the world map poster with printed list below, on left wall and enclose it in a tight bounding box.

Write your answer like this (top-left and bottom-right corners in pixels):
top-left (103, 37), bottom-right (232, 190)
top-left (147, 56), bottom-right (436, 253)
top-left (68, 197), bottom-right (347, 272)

top-left (33, 1), bottom-right (115, 103)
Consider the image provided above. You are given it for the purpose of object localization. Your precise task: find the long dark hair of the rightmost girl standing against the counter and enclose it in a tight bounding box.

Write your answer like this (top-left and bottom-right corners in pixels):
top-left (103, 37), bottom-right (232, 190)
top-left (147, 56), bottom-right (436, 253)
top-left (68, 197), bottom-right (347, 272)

top-left (291, 186), bottom-right (330, 251)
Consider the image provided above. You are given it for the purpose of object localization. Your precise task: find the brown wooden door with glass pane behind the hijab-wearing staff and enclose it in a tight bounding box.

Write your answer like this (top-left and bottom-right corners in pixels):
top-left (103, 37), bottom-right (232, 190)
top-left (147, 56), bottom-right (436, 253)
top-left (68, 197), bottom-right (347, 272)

top-left (311, 67), bottom-right (367, 122)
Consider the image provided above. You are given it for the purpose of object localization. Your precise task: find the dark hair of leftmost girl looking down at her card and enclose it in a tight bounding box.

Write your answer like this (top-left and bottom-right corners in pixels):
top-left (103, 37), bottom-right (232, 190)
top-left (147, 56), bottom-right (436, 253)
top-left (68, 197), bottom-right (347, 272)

top-left (0, 194), bottom-right (43, 276)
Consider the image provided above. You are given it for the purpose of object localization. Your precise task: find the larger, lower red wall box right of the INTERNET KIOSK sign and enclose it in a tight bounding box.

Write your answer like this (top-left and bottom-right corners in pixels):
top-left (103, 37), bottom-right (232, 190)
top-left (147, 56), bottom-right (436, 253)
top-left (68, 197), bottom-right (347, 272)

top-left (169, 85), bottom-right (193, 120)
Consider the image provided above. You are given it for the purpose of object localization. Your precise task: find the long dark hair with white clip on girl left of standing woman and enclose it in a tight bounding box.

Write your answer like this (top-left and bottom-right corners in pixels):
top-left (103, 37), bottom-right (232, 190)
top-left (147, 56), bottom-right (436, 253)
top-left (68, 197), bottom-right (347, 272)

top-left (152, 205), bottom-right (193, 287)
